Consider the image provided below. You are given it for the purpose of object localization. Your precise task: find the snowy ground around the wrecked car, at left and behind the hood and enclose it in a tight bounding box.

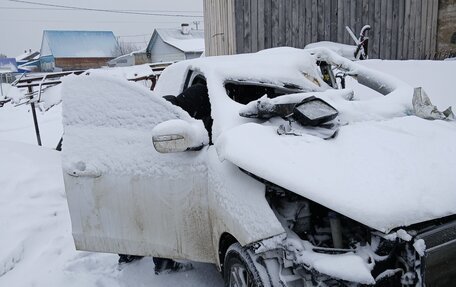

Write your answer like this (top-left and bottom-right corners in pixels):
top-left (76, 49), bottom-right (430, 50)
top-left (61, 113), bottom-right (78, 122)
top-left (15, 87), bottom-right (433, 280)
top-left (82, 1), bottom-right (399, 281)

top-left (0, 60), bottom-right (456, 286)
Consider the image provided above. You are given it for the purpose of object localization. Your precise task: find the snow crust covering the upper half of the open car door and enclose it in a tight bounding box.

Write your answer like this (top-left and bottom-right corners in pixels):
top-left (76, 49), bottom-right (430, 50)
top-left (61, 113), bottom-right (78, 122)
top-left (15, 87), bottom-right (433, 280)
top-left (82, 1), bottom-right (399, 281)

top-left (62, 75), bottom-right (207, 178)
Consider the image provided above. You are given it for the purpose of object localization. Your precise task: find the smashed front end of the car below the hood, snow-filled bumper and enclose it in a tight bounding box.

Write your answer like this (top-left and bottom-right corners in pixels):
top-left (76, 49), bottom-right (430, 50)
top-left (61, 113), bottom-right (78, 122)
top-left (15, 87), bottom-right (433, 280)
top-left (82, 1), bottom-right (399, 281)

top-left (253, 221), bottom-right (456, 286)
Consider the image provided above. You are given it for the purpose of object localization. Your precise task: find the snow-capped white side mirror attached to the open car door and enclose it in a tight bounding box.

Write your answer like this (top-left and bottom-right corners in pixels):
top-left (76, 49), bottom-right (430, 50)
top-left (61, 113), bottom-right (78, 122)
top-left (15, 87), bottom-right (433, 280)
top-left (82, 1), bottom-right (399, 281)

top-left (152, 119), bottom-right (209, 153)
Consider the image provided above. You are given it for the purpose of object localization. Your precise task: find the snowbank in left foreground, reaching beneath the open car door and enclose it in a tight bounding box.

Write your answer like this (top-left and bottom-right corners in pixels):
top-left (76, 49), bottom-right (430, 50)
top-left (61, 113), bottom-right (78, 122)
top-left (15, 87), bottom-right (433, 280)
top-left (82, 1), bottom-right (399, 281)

top-left (0, 142), bottom-right (223, 287)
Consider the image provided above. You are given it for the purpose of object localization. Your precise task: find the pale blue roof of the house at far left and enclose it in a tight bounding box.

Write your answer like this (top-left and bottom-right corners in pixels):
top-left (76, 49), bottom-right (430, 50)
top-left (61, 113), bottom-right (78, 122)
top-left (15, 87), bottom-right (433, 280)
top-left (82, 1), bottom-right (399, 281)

top-left (41, 30), bottom-right (118, 58)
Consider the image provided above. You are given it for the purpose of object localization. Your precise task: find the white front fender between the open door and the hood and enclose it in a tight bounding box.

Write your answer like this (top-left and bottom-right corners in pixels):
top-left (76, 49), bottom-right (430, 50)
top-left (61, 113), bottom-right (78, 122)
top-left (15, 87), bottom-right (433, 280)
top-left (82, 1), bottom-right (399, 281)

top-left (208, 148), bottom-right (285, 266)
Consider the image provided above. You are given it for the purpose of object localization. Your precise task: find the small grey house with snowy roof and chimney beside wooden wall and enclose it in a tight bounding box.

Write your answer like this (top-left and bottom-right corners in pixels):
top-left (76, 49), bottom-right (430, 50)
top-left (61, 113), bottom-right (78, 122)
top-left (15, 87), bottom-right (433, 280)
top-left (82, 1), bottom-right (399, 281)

top-left (146, 24), bottom-right (204, 63)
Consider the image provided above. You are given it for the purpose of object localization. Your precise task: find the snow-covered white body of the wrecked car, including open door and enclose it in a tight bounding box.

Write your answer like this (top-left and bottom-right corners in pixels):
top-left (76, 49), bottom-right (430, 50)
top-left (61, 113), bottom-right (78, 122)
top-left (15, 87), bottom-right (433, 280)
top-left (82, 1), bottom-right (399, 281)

top-left (62, 49), bottom-right (456, 283)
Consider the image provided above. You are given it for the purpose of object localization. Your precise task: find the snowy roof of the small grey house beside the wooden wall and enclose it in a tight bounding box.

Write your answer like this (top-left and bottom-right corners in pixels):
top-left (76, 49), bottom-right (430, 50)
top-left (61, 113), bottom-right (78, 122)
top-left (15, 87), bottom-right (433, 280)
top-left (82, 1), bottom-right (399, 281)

top-left (152, 28), bottom-right (204, 53)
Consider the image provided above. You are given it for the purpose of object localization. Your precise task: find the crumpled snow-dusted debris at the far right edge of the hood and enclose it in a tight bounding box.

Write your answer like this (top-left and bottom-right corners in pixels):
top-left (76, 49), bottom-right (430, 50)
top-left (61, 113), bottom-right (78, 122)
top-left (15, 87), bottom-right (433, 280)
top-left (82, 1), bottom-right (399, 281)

top-left (412, 87), bottom-right (454, 120)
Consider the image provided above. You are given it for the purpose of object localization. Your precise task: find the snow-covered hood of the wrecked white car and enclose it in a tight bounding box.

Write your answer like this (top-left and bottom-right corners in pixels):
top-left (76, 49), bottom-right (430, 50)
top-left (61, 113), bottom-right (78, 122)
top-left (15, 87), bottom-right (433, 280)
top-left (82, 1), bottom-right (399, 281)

top-left (216, 116), bottom-right (456, 233)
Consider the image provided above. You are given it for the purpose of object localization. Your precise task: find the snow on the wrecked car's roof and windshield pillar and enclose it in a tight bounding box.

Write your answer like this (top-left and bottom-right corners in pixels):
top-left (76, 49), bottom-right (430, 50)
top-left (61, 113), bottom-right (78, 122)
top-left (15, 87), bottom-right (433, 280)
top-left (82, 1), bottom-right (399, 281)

top-left (154, 48), bottom-right (330, 139)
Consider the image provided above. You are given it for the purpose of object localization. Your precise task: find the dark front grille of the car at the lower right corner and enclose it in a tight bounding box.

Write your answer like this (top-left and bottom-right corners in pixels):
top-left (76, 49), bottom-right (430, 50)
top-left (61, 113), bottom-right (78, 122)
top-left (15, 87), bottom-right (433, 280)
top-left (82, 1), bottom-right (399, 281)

top-left (416, 221), bottom-right (456, 287)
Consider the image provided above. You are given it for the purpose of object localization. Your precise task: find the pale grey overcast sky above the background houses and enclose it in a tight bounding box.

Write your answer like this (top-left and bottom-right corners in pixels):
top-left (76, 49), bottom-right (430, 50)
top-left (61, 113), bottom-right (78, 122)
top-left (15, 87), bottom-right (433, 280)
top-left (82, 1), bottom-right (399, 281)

top-left (0, 0), bottom-right (203, 57)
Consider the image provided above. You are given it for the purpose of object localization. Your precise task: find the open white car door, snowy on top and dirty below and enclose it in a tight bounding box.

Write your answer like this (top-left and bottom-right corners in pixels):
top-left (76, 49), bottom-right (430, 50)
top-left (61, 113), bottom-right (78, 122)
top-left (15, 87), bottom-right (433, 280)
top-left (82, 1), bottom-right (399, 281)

top-left (62, 76), bottom-right (214, 262)
